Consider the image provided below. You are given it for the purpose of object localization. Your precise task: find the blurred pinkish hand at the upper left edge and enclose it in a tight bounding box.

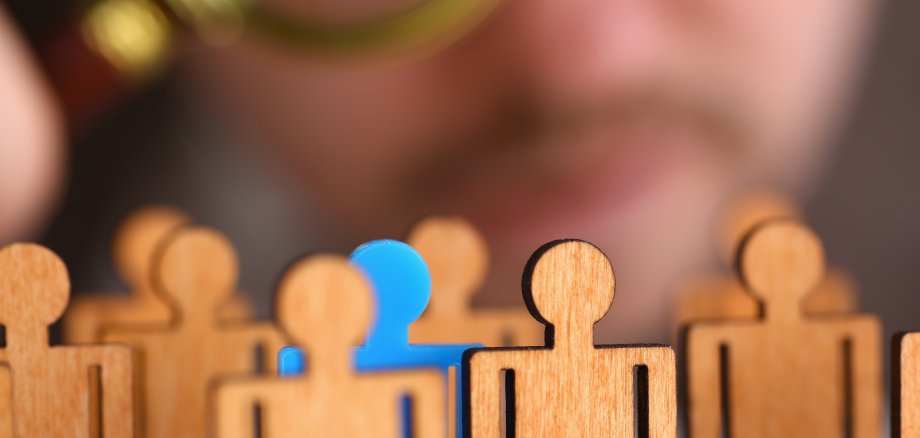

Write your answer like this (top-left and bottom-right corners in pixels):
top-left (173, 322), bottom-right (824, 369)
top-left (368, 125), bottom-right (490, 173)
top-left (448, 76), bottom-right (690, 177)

top-left (0, 5), bottom-right (64, 243)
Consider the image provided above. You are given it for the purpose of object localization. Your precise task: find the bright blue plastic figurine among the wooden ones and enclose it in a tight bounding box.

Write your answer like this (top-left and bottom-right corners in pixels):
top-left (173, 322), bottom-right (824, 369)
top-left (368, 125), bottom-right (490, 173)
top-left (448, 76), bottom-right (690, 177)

top-left (278, 240), bottom-right (482, 436)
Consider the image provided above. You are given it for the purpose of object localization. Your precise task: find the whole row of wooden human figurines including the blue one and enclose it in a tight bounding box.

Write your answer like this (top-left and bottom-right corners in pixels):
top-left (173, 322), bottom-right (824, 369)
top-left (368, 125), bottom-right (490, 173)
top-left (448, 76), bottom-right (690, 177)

top-left (0, 204), bottom-right (908, 437)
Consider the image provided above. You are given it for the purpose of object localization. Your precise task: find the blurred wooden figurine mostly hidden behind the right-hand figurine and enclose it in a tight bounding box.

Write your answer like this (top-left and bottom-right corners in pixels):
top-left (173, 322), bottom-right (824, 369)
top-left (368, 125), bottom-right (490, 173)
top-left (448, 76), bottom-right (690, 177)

top-left (675, 191), bottom-right (858, 327)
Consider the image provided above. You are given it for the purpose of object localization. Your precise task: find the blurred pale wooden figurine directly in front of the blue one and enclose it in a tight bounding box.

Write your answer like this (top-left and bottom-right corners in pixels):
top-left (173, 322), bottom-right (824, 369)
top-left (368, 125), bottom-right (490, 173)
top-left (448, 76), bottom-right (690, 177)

top-left (215, 255), bottom-right (447, 438)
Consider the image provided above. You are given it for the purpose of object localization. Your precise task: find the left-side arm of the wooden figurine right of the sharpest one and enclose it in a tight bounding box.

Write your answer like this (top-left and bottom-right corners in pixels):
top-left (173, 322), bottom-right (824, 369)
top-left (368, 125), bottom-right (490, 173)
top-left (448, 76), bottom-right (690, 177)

top-left (684, 325), bottom-right (731, 438)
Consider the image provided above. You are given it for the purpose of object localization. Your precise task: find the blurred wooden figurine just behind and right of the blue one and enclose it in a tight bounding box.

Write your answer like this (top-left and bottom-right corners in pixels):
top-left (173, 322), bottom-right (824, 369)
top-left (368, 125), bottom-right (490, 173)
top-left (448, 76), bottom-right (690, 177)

top-left (407, 217), bottom-right (543, 347)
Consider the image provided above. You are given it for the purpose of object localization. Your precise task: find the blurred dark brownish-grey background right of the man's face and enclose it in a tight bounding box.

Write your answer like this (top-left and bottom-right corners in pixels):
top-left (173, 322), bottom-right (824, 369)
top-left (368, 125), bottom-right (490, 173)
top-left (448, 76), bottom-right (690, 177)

top-left (807, 0), bottom-right (920, 342)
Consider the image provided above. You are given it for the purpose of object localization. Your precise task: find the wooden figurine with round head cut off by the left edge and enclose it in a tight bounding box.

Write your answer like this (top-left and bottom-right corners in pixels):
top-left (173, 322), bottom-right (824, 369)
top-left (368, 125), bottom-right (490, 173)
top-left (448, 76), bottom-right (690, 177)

top-left (0, 244), bottom-right (134, 438)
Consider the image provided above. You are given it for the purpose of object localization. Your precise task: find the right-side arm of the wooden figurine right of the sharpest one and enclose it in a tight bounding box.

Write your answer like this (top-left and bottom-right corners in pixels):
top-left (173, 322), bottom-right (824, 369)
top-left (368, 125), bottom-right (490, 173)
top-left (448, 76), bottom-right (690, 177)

top-left (845, 318), bottom-right (882, 438)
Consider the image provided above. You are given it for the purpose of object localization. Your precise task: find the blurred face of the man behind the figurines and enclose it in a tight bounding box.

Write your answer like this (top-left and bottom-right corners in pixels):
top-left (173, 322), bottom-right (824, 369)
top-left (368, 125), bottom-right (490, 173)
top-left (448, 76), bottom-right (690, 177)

top-left (192, 0), bottom-right (871, 340)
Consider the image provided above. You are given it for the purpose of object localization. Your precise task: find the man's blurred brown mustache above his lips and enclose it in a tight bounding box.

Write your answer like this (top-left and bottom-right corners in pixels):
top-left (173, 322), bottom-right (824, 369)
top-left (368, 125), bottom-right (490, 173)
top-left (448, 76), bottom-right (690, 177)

top-left (403, 81), bottom-right (752, 200)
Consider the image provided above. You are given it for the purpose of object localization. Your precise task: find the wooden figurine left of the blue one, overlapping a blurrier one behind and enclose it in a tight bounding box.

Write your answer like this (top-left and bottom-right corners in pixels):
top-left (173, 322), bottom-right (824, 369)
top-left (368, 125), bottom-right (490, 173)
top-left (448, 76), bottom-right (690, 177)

top-left (103, 227), bottom-right (286, 438)
